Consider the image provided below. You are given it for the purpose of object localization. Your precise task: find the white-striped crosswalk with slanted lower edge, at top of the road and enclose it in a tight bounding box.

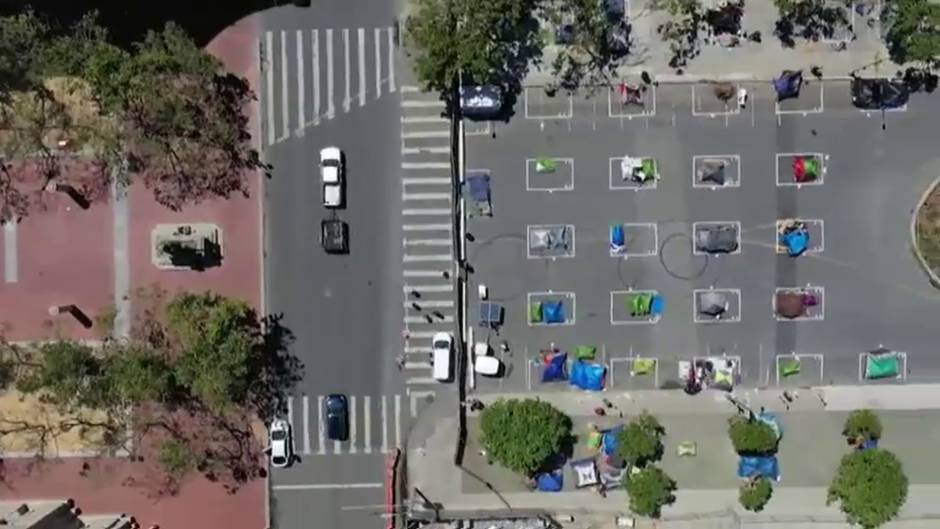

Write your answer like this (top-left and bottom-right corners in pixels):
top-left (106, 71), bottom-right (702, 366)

top-left (259, 26), bottom-right (397, 146)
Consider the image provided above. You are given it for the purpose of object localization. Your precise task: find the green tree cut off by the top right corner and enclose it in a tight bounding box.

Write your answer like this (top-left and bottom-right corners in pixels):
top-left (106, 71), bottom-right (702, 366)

top-left (885, 0), bottom-right (940, 66)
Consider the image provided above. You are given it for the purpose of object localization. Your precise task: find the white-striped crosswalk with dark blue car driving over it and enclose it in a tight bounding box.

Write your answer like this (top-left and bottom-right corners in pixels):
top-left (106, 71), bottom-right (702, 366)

top-left (284, 392), bottom-right (427, 456)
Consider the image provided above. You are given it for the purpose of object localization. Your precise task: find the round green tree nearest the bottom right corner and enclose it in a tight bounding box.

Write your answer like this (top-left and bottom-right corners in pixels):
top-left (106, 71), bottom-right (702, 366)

top-left (826, 448), bottom-right (908, 529)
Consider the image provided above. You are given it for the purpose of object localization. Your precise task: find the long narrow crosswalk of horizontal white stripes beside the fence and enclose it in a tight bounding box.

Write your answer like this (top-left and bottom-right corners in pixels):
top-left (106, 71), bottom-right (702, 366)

top-left (401, 86), bottom-right (456, 386)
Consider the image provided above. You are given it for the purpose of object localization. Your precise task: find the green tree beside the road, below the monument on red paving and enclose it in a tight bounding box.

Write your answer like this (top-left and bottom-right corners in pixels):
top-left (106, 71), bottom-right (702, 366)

top-left (166, 292), bottom-right (260, 411)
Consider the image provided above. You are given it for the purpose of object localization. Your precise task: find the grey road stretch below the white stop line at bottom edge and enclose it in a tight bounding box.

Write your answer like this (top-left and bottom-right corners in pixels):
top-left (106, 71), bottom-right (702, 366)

top-left (271, 483), bottom-right (386, 529)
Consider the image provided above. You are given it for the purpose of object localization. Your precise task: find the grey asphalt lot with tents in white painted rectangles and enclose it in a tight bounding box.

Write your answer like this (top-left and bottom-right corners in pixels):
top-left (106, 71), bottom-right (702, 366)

top-left (467, 81), bottom-right (940, 391)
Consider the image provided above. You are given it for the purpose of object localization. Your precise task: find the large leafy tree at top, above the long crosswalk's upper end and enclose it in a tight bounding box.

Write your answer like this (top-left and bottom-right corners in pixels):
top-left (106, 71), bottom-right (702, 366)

top-left (405, 0), bottom-right (541, 96)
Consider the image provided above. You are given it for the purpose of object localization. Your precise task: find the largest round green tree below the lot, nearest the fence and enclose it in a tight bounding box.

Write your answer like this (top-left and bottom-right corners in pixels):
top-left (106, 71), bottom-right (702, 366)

top-left (480, 399), bottom-right (571, 477)
